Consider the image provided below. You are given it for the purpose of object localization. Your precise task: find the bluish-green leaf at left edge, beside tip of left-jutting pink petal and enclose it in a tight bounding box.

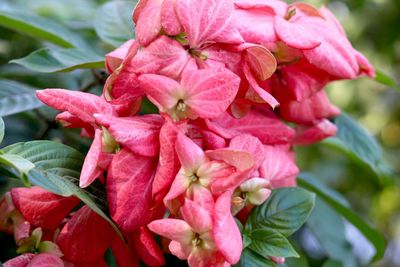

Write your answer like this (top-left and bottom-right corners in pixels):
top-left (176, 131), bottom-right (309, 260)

top-left (0, 80), bottom-right (43, 116)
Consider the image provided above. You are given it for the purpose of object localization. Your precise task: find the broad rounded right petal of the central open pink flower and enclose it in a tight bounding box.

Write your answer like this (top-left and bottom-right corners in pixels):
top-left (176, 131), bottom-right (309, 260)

top-left (181, 68), bottom-right (240, 118)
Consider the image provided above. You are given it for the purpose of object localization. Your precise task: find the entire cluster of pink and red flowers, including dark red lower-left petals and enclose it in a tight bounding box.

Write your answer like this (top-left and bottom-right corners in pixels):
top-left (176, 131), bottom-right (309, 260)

top-left (3, 0), bottom-right (374, 266)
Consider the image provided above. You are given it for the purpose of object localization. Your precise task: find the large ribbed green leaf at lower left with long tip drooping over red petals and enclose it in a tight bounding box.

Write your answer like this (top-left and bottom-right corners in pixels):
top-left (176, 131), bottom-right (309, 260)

top-left (3, 141), bottom-right (122, 241)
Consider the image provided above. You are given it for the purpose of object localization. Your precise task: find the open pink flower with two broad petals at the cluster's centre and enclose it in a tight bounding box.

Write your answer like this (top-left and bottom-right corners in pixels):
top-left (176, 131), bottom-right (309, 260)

top-left (139, 68), bottom-right (239, 121)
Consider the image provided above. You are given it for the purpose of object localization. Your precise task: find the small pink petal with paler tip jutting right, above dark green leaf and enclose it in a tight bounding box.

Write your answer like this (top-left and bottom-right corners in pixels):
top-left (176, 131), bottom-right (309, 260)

top-left (293, 119), bottom-right (337, 145)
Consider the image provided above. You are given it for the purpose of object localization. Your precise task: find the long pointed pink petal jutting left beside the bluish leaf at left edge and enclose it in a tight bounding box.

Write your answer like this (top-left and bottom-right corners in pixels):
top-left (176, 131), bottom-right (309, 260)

top-left (36, 89), bottom-right (115, 123)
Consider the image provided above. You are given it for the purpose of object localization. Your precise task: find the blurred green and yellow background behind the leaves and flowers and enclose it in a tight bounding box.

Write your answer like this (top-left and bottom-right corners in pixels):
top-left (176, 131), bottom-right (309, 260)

top-left (0, 0), bottom-right (400, 266)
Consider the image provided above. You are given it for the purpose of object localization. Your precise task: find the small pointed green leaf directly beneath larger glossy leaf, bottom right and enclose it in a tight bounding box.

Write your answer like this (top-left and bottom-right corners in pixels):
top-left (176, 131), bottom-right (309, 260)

top-left (248, 229), bottom-right (299, 258)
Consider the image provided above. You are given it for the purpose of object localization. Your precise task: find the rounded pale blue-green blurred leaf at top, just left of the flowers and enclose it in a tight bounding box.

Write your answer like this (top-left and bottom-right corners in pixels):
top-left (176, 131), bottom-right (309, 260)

top-left (94, 1), bottom-right (137, 46)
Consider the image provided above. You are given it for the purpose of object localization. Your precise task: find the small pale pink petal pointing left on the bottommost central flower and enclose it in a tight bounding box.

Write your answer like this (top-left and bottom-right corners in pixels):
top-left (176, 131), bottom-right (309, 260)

top-left (148, 218), bottom-right (193, 244)
